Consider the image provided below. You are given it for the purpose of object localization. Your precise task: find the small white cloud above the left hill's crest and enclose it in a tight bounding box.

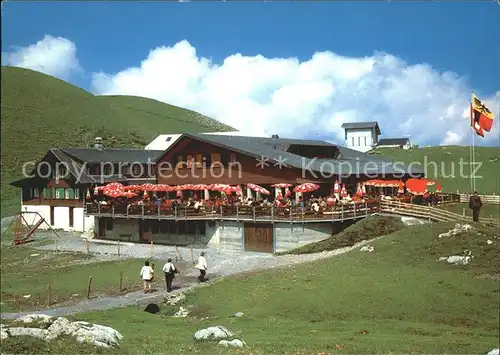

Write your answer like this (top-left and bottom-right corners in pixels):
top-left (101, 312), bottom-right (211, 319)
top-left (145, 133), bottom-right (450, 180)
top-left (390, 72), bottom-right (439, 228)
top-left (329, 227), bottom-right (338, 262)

top-left (2, 35), bottom-right (81, 79)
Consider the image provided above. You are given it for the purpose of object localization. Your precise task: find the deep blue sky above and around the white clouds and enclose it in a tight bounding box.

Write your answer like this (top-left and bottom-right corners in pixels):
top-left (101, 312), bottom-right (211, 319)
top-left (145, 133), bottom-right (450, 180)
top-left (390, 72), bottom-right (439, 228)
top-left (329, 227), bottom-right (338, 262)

top-left (2, 2), bottom-right (500, 145)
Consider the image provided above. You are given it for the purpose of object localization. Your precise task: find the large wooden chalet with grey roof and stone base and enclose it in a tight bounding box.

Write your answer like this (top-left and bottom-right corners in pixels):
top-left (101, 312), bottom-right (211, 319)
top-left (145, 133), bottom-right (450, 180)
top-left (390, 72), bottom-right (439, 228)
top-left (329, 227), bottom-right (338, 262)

top-left (9, 133), bottom-right (423, 252)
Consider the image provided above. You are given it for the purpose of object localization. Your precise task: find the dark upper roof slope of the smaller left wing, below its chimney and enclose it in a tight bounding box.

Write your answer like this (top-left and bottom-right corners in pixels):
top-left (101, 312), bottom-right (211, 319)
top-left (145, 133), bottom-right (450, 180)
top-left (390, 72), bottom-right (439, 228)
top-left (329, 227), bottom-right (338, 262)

top-left (59, 148), bottom-right (163, 164)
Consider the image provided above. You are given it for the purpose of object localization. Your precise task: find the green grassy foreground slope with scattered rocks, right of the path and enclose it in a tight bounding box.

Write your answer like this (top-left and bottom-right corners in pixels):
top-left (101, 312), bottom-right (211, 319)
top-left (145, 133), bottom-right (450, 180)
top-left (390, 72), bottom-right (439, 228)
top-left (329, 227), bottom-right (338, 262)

top-left (2, 224), bottom-right (500, 355)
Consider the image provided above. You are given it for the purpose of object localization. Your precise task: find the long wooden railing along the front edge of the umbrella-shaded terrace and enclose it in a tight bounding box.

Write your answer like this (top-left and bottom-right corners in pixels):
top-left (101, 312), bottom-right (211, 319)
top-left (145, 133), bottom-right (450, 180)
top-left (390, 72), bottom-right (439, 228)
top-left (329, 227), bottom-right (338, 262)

top-left (85, 201), bottom-right (379, 223)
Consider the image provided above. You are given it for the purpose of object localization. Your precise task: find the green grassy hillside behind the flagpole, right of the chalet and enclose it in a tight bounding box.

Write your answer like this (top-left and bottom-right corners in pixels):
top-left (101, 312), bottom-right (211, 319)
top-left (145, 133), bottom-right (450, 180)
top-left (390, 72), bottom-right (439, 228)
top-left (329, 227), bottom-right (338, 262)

top-left (373, 146), bottom-right (500, 194)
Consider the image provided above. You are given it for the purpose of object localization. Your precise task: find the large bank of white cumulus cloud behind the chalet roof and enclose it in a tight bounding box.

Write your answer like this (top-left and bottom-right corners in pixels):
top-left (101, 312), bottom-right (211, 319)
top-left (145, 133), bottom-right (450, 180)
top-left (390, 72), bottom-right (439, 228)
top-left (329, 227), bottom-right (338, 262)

top-left (89, 41), bottom-right (499, 144)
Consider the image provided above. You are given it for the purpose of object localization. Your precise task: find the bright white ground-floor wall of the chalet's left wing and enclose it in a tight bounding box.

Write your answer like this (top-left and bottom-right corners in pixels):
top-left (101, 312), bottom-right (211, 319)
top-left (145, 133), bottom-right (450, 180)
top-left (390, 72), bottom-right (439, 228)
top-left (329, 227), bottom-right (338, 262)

top-left (22, 205), bottom-right (95, 232)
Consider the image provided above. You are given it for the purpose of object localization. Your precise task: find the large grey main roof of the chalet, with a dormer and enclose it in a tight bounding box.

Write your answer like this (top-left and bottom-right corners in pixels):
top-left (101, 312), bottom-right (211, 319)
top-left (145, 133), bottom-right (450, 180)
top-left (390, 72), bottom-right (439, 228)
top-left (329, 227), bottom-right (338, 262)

top-left (163, 133), bottom-right (422, 175)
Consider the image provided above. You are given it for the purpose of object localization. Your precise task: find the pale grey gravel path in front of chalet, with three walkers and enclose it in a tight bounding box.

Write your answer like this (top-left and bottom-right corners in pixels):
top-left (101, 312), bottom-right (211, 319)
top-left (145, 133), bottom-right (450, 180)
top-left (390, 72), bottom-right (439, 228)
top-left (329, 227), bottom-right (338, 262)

top-left (1, 235), bottom-right (378, 319)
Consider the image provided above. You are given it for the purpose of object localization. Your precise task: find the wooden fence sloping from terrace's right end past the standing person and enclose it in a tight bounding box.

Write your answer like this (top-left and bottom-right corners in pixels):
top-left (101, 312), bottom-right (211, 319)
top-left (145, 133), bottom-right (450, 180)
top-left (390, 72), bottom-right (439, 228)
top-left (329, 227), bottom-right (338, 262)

top-left (380, 201), bottom-right (500, 227)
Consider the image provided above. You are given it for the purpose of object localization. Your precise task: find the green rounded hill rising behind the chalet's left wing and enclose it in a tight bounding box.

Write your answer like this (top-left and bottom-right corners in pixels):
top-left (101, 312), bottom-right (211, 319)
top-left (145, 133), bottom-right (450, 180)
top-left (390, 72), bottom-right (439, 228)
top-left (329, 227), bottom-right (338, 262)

top-left (1, 67), bottom-right (232, 216)
